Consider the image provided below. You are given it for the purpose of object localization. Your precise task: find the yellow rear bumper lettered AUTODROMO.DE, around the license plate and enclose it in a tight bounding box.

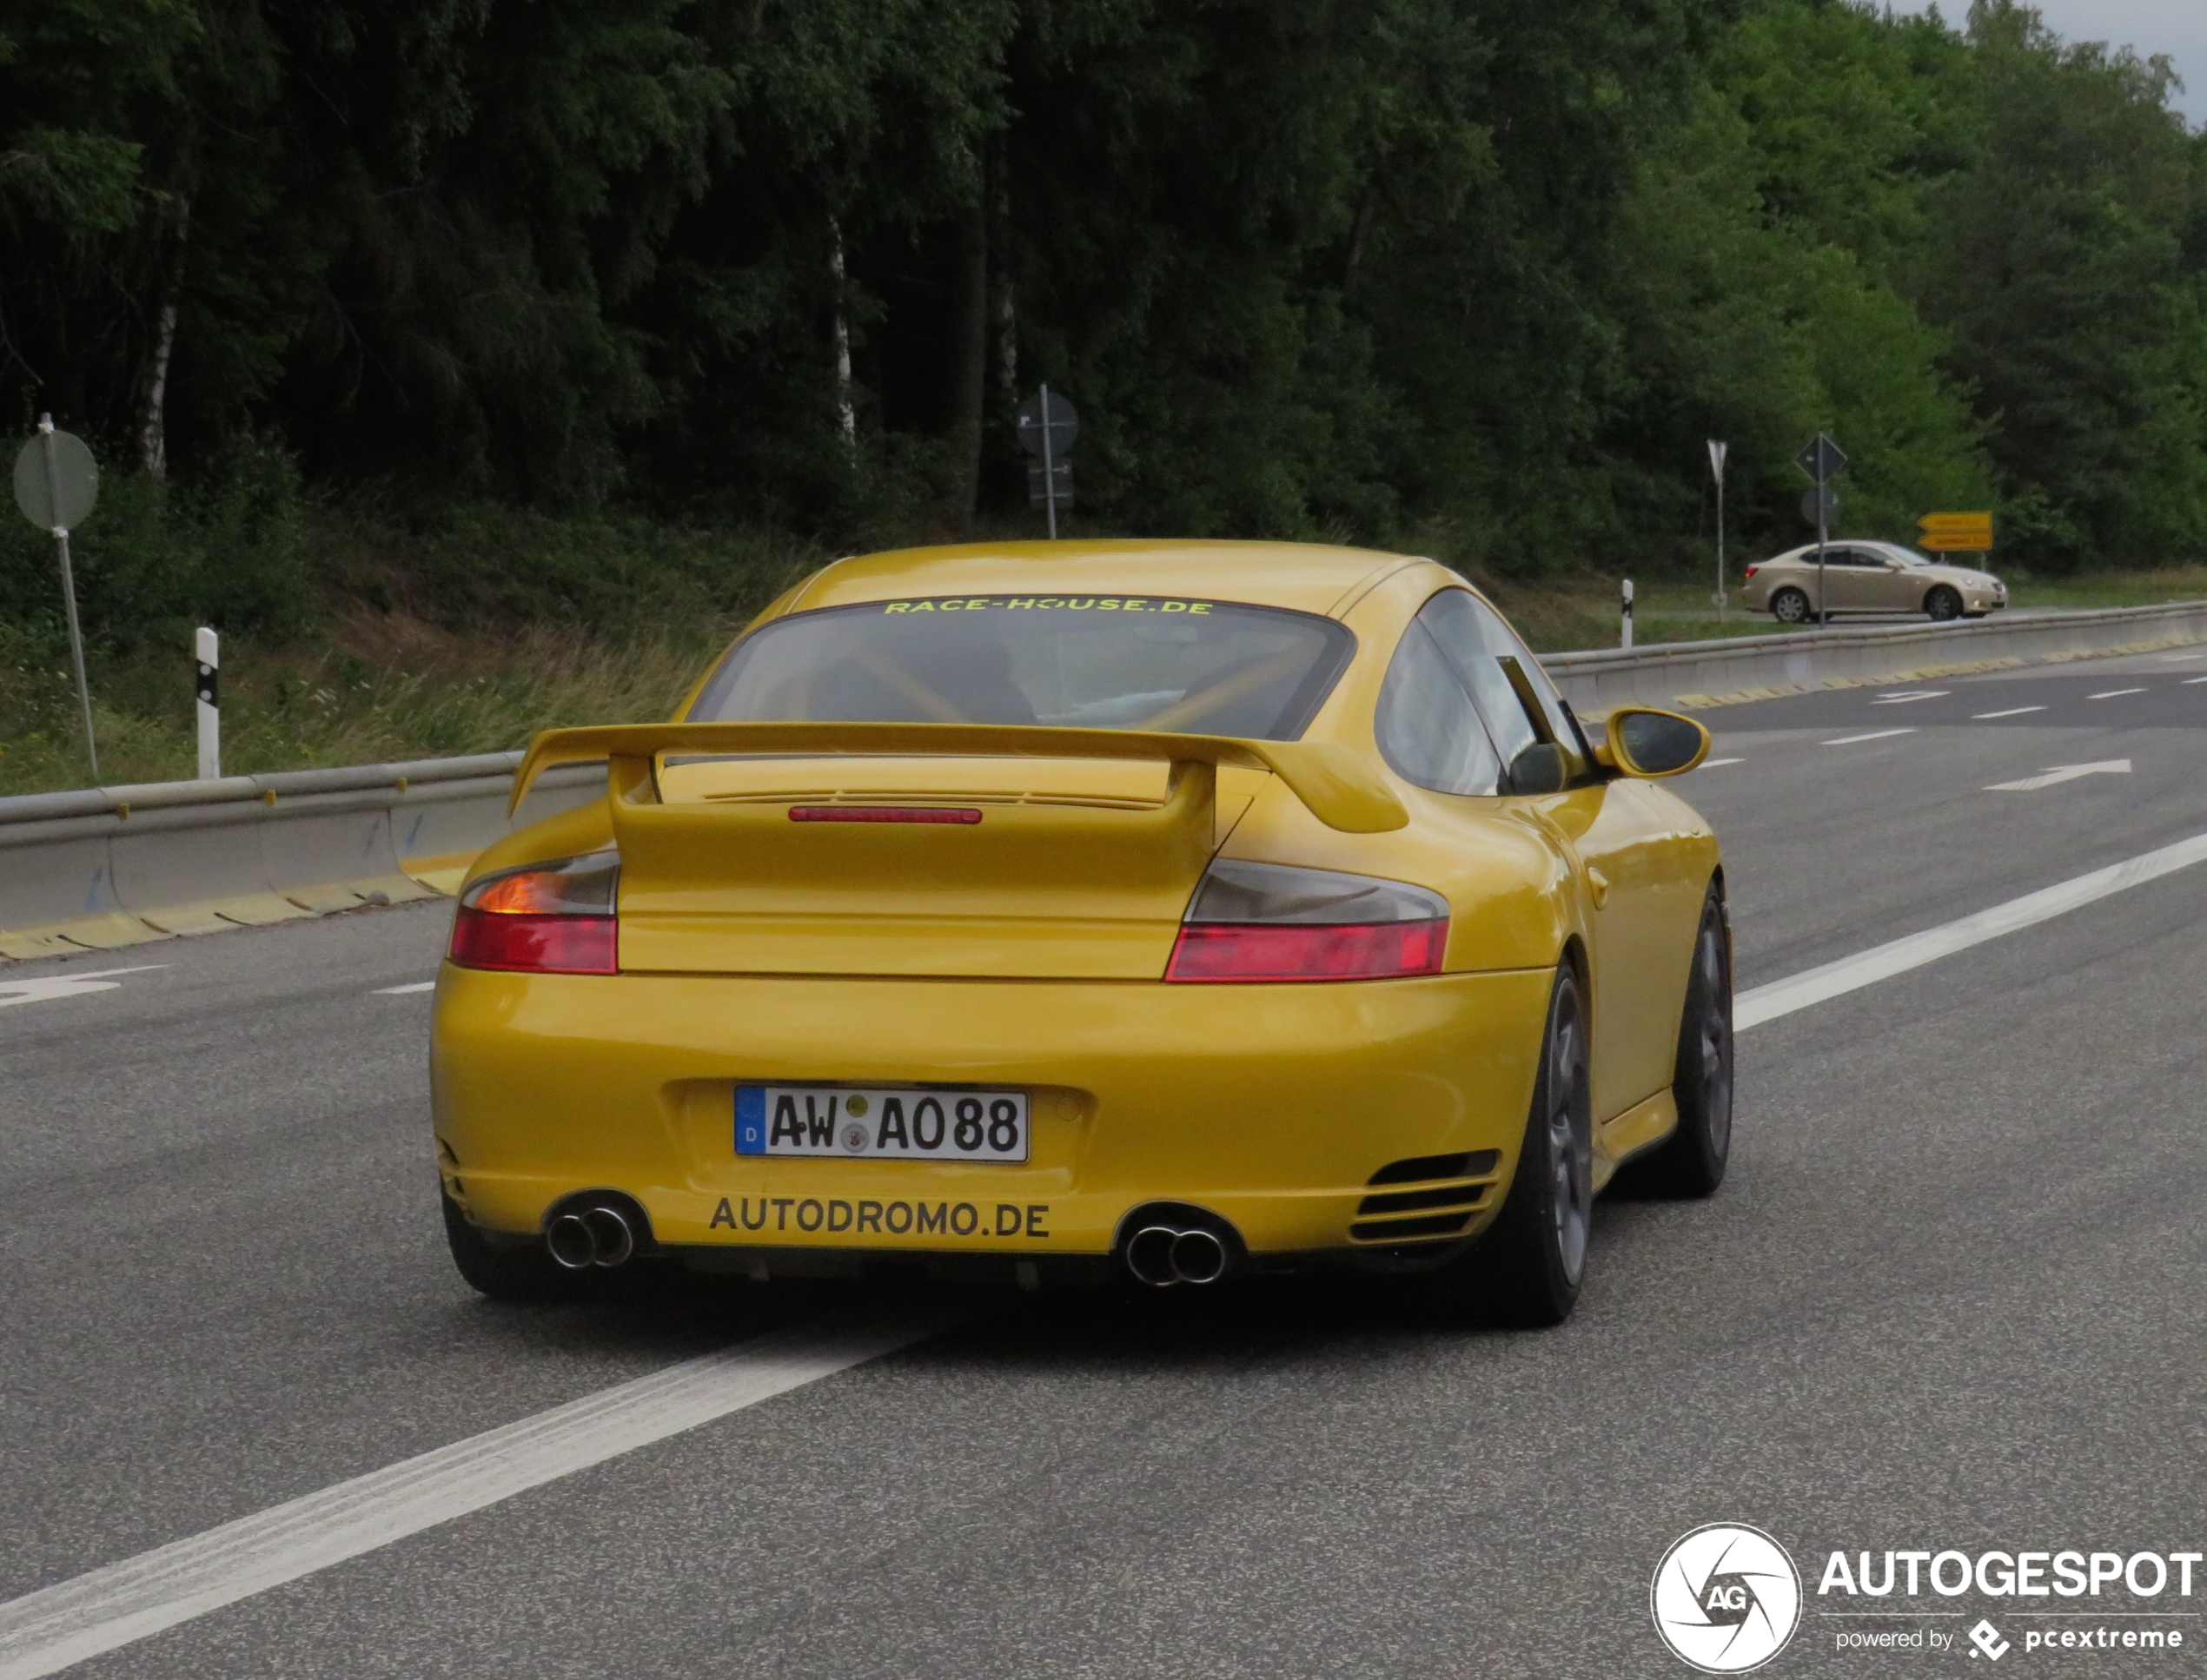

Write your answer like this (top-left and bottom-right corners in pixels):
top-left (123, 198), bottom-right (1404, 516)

top-left (433, 965), bottom-right (1549, 1256)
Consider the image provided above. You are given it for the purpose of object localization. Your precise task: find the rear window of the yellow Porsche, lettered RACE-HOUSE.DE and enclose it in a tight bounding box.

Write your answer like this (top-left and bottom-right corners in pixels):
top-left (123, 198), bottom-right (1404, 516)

top-left (688, 596), bottom-right (1355, 742)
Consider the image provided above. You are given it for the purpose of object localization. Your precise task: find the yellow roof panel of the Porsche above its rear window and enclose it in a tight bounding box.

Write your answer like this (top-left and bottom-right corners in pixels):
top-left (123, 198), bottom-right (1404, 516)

top-left (784, 539), bottom-right (1430, 614)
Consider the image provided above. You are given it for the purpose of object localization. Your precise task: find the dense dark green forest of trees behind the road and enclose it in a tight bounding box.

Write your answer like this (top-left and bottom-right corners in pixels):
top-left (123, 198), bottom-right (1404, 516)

top-left (0, 0), bottom-right (2207, 653)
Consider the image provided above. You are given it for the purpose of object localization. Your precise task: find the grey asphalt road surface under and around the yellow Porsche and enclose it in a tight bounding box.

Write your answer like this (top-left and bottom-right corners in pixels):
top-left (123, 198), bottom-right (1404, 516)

top-left (0, 640), bottom-right (2207, 1677)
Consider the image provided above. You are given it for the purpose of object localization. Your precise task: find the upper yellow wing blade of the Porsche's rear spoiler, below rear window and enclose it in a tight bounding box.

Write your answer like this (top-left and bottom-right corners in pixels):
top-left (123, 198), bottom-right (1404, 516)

top-left (507, 724), bottom-right (1410, 835)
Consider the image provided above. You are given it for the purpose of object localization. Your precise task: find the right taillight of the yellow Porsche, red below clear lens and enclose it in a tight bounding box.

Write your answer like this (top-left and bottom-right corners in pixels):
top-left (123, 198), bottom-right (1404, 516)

top-left (1165, 859), bottom-right (1448, 982)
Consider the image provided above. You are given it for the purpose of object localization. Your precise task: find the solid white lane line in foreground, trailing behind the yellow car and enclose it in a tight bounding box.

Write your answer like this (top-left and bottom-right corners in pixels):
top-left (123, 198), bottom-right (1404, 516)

top-left (0, 1313), bottom-right (964, 1680)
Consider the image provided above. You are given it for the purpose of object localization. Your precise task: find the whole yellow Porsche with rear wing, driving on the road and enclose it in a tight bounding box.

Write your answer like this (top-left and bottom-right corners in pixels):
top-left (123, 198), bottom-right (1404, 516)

top-left (433, 543), bottom-right (1733, 1322)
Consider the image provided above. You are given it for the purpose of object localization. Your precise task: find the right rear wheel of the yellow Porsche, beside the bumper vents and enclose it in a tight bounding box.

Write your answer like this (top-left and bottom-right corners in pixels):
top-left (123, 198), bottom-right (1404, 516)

top-left (1437, 962), bottom-right (1594, 1329)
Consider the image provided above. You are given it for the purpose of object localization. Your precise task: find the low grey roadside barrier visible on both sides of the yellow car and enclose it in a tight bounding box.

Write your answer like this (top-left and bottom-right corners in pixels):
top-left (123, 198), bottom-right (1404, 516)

top-left (0, 600), bottom-right (2207, 958)
